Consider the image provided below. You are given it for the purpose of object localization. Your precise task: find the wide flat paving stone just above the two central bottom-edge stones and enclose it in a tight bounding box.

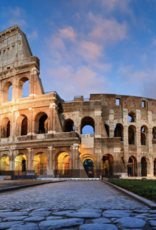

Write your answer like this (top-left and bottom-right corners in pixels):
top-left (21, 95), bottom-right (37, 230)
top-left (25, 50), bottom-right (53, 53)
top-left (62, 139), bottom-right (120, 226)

top-left (66, 211), bottom-right (101, 218)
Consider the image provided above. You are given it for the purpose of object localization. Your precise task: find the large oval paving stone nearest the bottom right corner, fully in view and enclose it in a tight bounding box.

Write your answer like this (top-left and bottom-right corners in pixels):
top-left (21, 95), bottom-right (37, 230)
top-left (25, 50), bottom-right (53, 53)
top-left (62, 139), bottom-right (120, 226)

top-left (115, 217), bottom-right (146, 228)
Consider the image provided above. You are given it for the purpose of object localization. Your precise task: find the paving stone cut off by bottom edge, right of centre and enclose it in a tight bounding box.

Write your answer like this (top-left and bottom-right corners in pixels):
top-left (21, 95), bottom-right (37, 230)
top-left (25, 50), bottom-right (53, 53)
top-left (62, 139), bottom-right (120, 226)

top-left (79, 223), bottom-right (118, 230)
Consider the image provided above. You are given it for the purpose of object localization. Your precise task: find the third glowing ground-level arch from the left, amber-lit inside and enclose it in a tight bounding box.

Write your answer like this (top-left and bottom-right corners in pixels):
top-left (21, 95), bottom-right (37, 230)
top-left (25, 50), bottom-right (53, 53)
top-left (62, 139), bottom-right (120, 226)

top-left (33, 153), bottom-right (48, 175)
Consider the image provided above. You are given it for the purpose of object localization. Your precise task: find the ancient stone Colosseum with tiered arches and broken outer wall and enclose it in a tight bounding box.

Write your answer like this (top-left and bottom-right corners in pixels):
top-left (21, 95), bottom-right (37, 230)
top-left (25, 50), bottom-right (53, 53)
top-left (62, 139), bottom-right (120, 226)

top-left (0, 25), bottom-right (156, 178)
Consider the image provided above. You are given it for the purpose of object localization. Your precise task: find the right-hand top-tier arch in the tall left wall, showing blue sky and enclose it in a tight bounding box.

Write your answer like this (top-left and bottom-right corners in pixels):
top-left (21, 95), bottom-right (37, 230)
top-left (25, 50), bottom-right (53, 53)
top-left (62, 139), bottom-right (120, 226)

top-left (18, 77), bottom-right (29, 98)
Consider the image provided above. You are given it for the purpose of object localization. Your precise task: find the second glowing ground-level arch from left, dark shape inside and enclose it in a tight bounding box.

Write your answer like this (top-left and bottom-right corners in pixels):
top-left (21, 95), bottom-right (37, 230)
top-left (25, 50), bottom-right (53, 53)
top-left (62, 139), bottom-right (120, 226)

top-left (15, 154), bottom-right (27, 173)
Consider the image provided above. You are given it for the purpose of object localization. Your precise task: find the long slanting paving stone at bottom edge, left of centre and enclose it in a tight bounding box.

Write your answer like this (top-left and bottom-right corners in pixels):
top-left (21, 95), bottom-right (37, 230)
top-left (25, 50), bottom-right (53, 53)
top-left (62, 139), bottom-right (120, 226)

top-left (39, 218), bottom-right (84, 230)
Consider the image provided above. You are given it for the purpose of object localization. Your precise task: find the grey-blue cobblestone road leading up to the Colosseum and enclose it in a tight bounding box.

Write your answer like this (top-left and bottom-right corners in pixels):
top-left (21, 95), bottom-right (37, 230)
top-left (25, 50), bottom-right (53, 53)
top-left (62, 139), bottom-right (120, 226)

top-left (0, 181), bottom-right (156, 230)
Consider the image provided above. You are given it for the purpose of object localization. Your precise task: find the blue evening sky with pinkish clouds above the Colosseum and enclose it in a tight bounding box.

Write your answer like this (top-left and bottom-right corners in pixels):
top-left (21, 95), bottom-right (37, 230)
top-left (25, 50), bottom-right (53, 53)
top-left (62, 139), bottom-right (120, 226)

top-left (0, 0), bottom-right (156, 101)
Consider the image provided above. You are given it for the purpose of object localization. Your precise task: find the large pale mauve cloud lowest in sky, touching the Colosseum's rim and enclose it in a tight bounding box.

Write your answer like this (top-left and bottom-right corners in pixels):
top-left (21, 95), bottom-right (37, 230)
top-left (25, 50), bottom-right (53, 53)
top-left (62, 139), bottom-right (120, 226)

top-left (48, 65), bottom-right (110, 99)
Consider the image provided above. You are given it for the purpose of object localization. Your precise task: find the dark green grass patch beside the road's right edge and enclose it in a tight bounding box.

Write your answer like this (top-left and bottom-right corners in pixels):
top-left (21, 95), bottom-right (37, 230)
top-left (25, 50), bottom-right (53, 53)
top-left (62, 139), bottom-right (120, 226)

top-left (109, 178), bottom-right (156, 201)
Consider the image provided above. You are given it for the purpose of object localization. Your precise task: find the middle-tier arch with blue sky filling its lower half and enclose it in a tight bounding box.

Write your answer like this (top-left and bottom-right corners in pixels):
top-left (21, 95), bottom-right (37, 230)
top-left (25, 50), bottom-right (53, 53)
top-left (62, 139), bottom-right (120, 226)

top-left (81, 117), bottom-right (95, 134)
